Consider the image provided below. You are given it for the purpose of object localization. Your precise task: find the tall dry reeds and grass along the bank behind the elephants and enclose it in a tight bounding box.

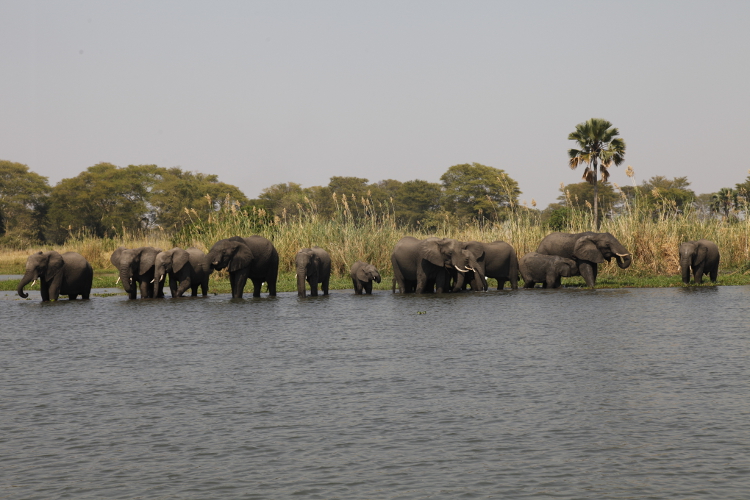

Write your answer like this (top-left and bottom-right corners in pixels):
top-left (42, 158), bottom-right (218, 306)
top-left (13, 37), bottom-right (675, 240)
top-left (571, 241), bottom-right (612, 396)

top-left (0, 191), bottom-right (750, 293)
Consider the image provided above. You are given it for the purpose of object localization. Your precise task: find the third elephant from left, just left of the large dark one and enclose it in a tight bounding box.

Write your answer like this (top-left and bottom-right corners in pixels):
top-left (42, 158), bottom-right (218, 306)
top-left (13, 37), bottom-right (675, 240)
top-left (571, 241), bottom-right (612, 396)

top-left (154, 247), bottom-right (211, 297)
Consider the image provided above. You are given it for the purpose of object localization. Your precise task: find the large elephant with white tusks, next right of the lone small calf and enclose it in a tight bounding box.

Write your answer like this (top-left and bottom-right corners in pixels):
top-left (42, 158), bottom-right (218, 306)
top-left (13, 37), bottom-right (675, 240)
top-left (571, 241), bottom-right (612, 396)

top-left (391, 236), bottom-right (484, 293)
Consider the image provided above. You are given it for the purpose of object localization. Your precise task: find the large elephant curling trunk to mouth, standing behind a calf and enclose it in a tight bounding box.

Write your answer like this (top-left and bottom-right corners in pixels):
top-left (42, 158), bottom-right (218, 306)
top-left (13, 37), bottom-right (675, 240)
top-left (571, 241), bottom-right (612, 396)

top-left (536, 231), bottom-right (632, 288)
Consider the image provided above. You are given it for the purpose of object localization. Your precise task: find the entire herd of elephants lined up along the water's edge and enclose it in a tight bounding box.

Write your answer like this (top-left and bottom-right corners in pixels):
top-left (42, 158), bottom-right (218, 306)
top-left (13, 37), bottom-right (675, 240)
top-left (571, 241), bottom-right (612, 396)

top-left (17, 232), bottom-right (719, 301)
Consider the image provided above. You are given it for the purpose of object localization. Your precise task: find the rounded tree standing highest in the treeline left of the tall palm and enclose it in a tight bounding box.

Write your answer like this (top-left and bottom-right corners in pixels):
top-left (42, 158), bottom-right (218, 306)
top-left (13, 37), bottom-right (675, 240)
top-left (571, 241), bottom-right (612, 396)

top-left (440, 163), bottom-right (521, 222)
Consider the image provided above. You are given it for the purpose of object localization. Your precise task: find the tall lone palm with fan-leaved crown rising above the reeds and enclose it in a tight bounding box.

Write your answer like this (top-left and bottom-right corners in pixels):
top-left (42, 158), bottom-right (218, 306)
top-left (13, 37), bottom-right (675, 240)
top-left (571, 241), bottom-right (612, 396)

top-left (568, 118), bottom-right (625, 231)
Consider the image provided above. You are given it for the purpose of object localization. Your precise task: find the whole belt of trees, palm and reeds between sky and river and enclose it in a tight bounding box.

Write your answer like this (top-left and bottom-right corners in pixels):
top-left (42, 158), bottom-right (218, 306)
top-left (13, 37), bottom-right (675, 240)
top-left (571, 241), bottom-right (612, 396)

top-left (0, 118), bottom-right (750, 293)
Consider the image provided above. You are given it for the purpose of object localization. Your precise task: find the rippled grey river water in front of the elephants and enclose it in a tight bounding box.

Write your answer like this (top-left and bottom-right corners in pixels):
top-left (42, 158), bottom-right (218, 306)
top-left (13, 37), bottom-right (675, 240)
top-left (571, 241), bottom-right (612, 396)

top-left (0, 287), bottom-right (750, 500)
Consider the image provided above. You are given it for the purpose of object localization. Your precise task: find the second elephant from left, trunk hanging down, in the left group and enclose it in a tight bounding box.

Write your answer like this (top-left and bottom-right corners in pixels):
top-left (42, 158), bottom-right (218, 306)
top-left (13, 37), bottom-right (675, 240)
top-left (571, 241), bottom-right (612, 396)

top-left (109, 247), bottom-right (161, 299)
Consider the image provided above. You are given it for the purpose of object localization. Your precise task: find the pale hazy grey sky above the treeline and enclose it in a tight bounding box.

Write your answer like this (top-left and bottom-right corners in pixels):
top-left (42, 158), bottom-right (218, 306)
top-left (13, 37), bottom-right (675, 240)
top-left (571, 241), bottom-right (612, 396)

top-left (0, 0), bottom-right (750, 208)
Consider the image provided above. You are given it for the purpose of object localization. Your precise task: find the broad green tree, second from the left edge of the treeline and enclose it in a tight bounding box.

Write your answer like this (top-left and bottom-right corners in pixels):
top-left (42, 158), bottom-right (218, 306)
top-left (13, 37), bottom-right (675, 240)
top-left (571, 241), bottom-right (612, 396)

top-left (48, 163), bottom-right (159, 242)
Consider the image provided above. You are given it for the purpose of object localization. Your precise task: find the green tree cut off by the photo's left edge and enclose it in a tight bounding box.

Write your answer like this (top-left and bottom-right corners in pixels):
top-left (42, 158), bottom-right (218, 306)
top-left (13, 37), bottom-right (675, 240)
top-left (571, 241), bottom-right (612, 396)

top-left (0, 160), bottom-right (50, 246)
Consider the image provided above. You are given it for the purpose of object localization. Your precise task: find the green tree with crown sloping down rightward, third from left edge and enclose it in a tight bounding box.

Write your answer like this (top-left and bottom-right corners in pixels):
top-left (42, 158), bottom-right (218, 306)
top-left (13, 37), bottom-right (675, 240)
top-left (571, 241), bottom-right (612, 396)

top-left (147, 167), bottom-right (248, 231)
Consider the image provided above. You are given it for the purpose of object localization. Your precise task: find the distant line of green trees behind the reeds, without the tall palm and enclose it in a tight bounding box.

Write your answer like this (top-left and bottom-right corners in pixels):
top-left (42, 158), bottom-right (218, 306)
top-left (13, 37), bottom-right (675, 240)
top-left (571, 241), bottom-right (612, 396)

top-left (0, 160), bottom-right (750, 248)
